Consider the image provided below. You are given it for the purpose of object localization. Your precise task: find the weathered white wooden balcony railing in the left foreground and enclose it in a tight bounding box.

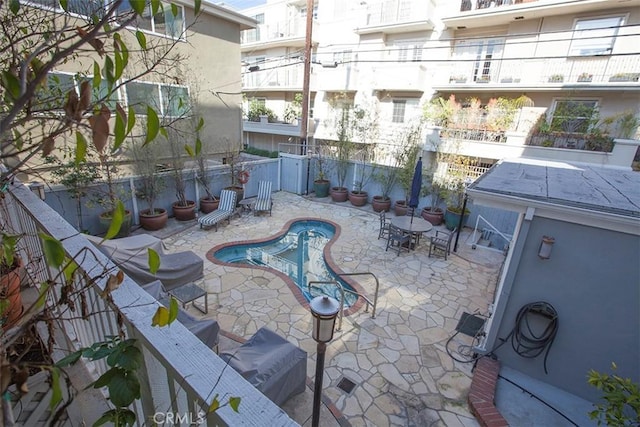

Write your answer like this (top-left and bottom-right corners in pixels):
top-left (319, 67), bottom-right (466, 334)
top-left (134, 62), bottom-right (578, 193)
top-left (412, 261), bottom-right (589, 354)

top-left (0, 184), bottom-right (297, 426)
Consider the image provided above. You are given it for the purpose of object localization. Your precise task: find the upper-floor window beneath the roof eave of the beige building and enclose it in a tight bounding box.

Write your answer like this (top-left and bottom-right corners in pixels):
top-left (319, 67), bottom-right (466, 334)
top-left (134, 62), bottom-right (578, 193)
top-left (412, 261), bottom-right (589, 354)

top-left (117, 0), bottom-right (184, 39)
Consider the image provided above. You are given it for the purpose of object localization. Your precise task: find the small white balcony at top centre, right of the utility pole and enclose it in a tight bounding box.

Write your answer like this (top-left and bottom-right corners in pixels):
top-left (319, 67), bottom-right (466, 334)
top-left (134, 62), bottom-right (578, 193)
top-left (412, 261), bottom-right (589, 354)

top-left (355, 0), bottom-right (435, 34)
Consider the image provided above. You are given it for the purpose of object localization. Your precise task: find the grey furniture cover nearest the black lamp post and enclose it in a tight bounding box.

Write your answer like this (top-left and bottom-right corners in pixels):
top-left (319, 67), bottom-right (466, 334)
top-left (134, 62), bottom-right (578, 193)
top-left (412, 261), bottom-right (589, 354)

top-left (220, 327), bottom-right (307, 405)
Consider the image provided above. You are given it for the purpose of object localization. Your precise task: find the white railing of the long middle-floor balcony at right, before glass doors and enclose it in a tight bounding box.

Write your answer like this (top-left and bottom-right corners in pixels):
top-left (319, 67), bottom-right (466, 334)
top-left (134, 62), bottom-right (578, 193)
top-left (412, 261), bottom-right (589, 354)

top-left (440, 55), bottom-right (640, 86)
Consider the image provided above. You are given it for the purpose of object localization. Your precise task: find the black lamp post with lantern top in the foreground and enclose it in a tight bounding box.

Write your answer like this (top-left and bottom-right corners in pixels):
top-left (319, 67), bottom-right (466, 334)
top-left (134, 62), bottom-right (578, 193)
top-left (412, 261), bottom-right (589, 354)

top-left (307, 296), bottom-right (340, 427)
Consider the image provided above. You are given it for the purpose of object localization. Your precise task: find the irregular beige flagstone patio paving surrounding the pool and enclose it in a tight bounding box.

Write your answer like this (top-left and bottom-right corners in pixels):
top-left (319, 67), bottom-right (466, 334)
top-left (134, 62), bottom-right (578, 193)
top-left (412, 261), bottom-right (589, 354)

top-left (158, 192), bottom-right (504, 427)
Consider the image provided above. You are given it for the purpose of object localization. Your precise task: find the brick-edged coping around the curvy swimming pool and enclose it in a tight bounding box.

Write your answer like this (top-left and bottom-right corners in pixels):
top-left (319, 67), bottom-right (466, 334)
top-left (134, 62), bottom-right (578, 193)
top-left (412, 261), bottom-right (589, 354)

top-left (205, 217), bottom-right (365, 316)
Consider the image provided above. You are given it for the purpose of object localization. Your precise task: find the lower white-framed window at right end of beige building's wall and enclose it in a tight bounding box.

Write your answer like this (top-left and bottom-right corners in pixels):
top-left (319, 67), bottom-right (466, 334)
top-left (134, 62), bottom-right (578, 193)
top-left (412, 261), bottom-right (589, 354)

top-left (126, 82), bottom-right (189, 117)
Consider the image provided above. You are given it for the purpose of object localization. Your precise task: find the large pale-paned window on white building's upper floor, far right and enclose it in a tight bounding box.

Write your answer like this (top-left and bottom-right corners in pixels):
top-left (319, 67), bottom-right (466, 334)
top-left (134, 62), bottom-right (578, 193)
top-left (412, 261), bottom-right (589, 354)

top-left (569, 16), bottom-right (624, 56)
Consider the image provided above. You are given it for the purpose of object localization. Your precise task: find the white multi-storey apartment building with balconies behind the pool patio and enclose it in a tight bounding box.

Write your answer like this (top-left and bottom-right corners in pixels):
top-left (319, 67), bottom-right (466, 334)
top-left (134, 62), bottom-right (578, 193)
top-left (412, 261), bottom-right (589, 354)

top-left (235, 0), bottom-right (640, 168)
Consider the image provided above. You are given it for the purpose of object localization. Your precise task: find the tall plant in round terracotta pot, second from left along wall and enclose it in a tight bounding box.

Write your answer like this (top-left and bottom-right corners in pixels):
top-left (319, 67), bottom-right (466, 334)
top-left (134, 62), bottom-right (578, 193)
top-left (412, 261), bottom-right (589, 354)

top-left (131, 141), bottom-right (169, 231)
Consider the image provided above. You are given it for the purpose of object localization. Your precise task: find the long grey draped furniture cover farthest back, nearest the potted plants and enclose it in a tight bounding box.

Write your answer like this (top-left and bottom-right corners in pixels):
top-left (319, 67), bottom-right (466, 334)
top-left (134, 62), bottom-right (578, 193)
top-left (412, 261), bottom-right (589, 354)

top-left (86, 234), bottom-right (204, 290)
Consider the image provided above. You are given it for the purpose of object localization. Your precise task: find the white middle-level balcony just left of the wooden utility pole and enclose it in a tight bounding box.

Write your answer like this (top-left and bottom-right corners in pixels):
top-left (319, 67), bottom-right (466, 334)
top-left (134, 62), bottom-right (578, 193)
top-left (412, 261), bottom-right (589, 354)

top-left (242, 62), bottom-right (304, 92)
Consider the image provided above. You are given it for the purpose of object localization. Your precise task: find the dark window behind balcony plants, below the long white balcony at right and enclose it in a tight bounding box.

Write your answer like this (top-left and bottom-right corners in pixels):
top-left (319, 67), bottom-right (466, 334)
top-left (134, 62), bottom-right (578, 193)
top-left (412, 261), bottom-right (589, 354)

top-left (551, 99), bottom-right (598, 133)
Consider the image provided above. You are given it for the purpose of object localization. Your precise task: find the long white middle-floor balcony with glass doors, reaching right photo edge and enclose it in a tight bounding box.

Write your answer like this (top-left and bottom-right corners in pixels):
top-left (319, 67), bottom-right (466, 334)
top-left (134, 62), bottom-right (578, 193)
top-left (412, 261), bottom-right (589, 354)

top-left (434, 55), bottom-right (640, 92)
